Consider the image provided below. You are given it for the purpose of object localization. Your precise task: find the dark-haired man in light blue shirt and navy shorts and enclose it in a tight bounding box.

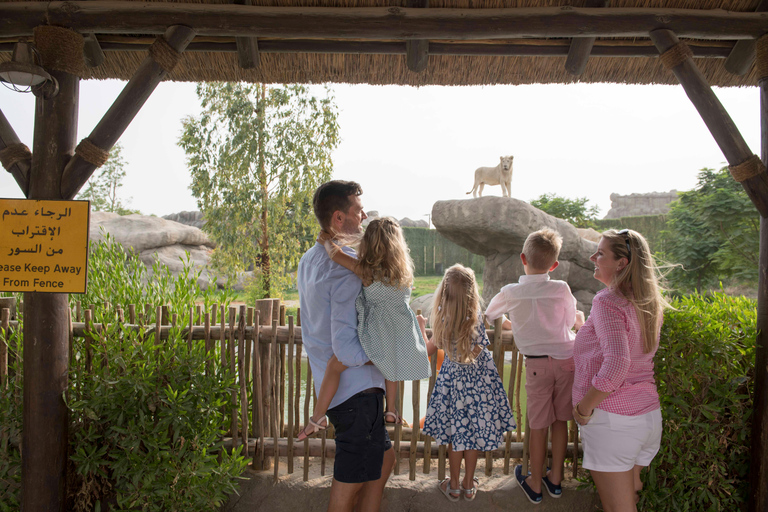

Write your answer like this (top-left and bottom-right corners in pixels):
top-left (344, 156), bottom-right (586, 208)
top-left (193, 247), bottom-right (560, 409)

top-left (297, 180), bottom-right (395, 512)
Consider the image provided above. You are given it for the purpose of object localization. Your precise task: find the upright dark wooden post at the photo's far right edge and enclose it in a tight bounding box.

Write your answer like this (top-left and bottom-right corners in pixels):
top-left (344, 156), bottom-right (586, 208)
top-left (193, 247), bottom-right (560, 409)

top-left (748, 75), bottom-right (768, 512)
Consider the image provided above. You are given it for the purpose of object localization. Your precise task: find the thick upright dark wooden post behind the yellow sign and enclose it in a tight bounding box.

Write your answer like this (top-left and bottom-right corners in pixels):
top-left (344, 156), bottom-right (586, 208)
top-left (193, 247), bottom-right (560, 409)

top-left (21, 59), bottom-right (80, 511)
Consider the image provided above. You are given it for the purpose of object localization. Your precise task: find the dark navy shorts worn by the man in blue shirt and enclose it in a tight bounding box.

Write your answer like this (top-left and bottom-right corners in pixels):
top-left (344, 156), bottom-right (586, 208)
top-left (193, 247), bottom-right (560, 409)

top-left (327, 390), bottom-right (392, 484)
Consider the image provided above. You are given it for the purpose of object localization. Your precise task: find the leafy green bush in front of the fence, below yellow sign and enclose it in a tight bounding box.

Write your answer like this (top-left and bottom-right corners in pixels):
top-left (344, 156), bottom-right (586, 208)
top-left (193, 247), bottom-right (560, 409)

top-left (0, 237), bottom-right (246, 511)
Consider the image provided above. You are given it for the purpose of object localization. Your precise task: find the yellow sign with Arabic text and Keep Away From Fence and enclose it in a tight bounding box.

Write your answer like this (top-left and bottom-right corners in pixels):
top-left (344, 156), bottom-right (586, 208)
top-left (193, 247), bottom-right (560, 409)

top-left (0, 199), bottom-right (90, 293)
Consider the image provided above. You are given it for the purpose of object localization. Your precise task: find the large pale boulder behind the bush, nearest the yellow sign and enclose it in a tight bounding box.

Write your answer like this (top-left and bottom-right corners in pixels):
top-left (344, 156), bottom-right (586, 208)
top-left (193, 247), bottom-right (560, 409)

top-left (89, 212), bottom-right (237, 288)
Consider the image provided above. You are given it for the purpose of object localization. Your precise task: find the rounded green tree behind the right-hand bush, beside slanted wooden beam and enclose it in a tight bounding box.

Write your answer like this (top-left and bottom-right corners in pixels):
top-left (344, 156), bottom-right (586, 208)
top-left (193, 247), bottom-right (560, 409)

top-left (662, 167), bottom-right (760, 291)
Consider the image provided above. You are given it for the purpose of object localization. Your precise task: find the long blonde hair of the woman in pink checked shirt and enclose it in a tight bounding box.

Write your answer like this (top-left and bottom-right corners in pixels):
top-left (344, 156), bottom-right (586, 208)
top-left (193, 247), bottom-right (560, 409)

top-left (602, 229), bottom-right (669, 354)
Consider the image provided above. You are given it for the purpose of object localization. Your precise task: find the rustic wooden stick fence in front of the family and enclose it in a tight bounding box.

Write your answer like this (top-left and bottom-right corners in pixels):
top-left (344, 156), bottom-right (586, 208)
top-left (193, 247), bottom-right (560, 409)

top-left (0, 299), bottom-right (580, 481)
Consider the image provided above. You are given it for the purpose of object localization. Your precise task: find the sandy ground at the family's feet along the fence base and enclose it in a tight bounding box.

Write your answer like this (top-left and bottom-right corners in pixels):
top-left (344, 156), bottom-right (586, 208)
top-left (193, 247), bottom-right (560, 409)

top-left (221, 457), bottom-right (600, 512)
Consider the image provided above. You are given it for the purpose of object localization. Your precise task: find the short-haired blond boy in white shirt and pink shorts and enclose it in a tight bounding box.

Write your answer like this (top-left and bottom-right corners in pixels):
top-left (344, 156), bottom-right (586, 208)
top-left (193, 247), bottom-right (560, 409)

top-left (485, 229), bottom-right (584, 504)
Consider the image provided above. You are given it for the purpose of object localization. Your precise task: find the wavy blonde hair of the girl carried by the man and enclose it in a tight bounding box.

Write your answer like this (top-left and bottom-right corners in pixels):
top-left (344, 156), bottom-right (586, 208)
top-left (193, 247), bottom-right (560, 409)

top-left (357, 217), bottom-right (413, 288)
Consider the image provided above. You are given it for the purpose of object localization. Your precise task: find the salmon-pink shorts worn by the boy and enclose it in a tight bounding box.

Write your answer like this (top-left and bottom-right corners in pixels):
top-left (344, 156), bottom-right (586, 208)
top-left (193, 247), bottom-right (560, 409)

top-left (525, 357), bottom-right (574, 429)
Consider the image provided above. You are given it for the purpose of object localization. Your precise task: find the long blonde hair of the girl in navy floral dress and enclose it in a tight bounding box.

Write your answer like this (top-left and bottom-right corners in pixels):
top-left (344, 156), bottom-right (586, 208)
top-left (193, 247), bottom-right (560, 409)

top-left (430, 264), bottom-right (480, 363)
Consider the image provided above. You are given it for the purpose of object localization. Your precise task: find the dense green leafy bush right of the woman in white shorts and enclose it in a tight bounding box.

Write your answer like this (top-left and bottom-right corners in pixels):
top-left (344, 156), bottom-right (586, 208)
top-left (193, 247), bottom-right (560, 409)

top-left (638, 293), bottom-right (757, 512)
